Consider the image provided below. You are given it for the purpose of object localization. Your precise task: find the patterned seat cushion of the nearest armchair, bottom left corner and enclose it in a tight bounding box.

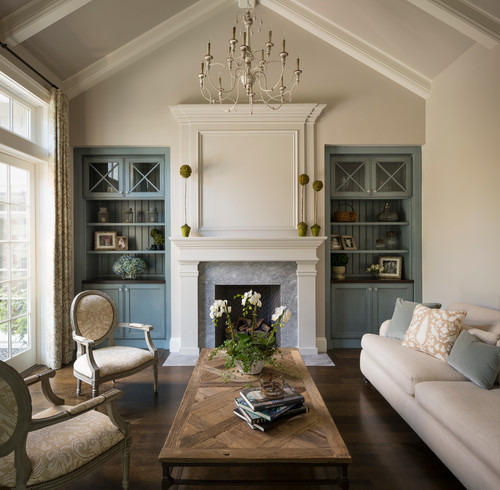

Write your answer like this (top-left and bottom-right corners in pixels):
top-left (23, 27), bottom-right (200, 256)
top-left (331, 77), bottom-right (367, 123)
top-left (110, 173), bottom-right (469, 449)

top-left (0, 410), bottom-right (125, 488)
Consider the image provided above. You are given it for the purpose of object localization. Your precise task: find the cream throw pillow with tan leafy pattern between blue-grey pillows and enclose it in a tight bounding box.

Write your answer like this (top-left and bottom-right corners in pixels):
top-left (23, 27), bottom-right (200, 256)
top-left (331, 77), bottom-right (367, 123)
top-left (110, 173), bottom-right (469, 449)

top-left (401, 305), bottom-right (467, 361)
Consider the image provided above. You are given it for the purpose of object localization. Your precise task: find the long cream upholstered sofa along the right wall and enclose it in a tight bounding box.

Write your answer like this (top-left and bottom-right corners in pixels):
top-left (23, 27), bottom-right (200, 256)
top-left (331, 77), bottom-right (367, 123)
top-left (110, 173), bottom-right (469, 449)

top-left (360, 303), bottom-right (500, 490)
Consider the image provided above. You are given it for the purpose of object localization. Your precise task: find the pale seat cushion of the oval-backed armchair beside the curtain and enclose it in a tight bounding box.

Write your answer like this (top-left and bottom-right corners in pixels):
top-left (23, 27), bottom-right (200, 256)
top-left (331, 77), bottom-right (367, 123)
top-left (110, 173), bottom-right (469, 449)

top-left (73, 345), bottom-right (154, 378)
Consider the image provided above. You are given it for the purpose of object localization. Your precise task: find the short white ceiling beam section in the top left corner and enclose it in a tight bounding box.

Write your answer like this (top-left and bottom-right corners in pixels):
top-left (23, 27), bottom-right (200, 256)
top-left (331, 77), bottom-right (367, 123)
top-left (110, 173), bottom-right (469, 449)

top-left (0, 0), bottom-right (92, 47)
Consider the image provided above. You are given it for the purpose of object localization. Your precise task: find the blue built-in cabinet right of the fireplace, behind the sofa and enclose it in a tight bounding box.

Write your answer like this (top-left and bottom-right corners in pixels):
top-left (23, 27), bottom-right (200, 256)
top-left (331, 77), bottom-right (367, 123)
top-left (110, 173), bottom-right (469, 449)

top-left (325, 146), bottom-right (422, 348)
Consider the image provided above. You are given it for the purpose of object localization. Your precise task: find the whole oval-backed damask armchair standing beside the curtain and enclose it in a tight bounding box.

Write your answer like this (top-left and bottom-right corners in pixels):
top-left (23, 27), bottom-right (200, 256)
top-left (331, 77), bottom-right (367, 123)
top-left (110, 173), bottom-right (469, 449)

top-left (71, 290), bottom-right (158, 396)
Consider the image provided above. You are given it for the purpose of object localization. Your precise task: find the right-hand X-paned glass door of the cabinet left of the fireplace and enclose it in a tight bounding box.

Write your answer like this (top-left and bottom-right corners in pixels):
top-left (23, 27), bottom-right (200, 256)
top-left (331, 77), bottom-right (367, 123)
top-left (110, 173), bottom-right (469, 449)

top-left (127, 158), bottom-right (164, 197)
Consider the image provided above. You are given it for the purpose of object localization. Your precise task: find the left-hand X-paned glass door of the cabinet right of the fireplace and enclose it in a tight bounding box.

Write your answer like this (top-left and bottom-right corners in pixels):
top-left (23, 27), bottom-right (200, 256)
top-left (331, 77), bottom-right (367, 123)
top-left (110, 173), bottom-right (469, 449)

top-left (330, 155), bottom-right (370, 197)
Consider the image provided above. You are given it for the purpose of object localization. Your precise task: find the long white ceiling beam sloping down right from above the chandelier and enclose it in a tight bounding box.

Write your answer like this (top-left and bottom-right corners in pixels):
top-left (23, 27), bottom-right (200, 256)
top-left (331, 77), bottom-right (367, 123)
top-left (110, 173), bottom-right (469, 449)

top-left (259, 0), bottom-right (431, 98)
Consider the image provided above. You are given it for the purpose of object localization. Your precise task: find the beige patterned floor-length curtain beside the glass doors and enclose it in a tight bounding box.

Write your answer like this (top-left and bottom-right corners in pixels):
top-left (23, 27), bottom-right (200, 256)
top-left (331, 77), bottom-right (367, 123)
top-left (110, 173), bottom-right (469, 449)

top-left (47, 88), bottom-right (73, 369)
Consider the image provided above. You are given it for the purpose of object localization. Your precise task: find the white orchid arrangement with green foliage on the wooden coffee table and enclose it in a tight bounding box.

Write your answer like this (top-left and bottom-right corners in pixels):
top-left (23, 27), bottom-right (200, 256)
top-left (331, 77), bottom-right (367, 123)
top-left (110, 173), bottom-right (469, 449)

top-left (210, 290), bottom-right (292, 380)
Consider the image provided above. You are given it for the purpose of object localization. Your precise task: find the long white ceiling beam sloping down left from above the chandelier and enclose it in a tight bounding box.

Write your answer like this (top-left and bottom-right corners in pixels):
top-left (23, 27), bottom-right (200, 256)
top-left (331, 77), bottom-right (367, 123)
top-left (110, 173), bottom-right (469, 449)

top-left (63, 0), bottom-right (235, 99)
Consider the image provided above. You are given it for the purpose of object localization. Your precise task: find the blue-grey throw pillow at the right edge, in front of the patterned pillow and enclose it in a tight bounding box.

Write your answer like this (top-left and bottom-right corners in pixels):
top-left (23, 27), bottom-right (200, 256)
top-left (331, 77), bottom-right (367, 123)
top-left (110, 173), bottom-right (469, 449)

top-left (448, 330), bottom-right (500, 388)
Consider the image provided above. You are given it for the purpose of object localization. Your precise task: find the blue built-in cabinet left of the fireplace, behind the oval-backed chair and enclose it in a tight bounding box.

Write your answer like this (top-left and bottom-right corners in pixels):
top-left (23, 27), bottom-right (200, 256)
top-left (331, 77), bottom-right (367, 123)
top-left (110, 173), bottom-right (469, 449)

top-left (74, 147), bottom-right (170, 348)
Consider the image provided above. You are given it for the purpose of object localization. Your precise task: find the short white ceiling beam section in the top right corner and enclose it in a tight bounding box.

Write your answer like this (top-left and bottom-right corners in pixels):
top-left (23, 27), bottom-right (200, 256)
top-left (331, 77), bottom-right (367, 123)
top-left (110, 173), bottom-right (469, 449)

top-left (407, 0), bottom-right (500, 49)
